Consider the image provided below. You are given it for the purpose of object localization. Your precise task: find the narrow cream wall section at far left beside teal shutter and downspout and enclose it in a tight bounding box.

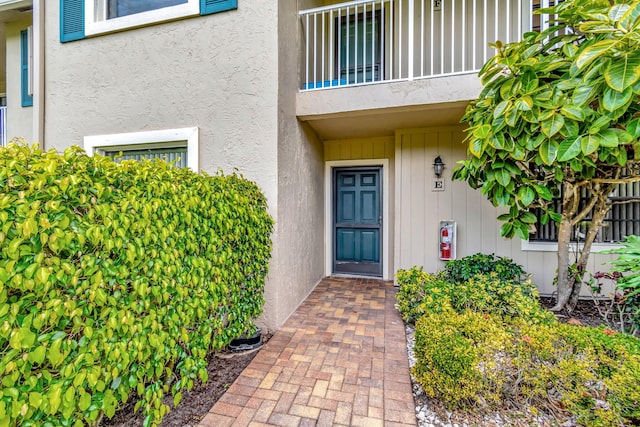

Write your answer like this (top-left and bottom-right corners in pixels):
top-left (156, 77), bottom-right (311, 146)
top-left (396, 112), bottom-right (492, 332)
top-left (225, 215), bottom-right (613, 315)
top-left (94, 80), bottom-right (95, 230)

top-left (5, 17), bottom-right (34, 142)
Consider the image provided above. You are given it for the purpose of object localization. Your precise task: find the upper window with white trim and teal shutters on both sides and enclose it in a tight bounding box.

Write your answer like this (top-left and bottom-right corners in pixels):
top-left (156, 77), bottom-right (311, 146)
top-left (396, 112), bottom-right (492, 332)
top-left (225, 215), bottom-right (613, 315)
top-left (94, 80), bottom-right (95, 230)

top-left (60, 0), bottom-right (238, 42)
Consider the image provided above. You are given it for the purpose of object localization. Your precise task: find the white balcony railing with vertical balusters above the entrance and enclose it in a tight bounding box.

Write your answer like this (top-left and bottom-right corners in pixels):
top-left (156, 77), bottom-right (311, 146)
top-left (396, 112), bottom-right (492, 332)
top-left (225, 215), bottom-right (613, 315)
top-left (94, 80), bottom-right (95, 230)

top-left (300, 0), bottom-right (553, 90)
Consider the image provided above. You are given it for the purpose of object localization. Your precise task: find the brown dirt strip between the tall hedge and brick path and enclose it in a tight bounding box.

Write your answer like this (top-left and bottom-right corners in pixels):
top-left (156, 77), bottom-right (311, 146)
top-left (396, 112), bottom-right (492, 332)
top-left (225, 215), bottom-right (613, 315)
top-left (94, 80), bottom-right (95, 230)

top-left (100, 350), bottom-right (257, 427)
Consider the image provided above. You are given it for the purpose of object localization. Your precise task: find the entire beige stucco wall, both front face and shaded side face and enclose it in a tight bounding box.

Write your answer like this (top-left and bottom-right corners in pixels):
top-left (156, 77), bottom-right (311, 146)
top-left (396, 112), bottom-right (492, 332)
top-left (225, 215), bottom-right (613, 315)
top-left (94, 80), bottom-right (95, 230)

top-left (45, 0), bottom-right (324, 330)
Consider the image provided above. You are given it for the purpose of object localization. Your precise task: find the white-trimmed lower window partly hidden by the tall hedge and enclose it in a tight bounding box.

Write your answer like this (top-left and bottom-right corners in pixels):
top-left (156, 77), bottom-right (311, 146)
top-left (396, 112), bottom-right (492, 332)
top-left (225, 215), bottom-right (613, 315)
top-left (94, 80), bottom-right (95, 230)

top-left (84, 127), bottom-right (199, 172)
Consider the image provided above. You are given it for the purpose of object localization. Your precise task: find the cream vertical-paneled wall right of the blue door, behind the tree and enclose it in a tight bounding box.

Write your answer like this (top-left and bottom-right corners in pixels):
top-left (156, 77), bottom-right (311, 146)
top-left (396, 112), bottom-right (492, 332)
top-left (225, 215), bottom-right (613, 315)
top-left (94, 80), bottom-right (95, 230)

top-left (396, 126), bottom-right (614, 295)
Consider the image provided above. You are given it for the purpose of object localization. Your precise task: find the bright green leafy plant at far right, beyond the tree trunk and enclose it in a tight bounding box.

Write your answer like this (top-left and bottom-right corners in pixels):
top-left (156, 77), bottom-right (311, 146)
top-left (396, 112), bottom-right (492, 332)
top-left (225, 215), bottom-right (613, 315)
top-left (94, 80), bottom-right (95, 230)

top-left (611, 236), bottom-right (640, 331)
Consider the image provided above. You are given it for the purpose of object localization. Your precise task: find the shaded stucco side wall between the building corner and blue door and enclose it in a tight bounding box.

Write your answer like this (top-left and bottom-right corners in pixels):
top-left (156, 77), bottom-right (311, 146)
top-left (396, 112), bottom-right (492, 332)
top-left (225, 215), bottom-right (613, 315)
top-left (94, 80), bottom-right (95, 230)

top-left (264, 2), bottom-right (324, 326)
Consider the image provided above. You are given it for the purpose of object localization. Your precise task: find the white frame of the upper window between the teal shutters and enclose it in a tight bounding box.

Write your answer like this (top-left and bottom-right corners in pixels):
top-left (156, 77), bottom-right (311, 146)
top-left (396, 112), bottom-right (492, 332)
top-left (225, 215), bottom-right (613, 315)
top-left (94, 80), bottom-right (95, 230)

top-left (84, 0), bottom-right (200, 36)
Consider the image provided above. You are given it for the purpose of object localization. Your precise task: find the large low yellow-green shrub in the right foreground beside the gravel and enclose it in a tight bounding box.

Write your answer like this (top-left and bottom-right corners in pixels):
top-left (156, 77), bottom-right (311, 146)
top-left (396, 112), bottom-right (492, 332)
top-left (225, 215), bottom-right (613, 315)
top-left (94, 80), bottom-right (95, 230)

top-left (412, 309), bottom-right (640, 426)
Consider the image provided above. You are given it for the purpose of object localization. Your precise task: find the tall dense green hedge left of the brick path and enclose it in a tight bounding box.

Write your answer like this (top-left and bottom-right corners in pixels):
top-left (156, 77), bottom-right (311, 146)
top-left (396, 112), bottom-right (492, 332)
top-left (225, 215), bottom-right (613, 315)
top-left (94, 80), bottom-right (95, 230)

top-left (0, 144), bottom-right (273, 426)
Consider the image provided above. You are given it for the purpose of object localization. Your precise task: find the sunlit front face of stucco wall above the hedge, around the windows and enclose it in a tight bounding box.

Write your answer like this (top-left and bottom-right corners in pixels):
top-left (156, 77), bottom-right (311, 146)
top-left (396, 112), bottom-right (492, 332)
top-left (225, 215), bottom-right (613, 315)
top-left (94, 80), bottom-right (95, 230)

top-left (45, 0), bottom-right (292, 329)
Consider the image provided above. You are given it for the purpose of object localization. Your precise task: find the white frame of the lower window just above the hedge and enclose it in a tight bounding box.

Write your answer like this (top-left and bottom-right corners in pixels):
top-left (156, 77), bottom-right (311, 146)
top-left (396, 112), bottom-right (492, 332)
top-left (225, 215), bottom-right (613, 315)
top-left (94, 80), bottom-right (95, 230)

top-left (84, 127), bottom-right (200, 173)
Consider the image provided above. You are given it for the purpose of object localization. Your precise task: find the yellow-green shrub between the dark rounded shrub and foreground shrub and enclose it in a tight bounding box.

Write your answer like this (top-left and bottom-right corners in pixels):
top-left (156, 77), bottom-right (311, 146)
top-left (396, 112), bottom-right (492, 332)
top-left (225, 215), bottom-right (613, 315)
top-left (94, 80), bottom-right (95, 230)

top-left (396, 267), bottom-right (555, 323)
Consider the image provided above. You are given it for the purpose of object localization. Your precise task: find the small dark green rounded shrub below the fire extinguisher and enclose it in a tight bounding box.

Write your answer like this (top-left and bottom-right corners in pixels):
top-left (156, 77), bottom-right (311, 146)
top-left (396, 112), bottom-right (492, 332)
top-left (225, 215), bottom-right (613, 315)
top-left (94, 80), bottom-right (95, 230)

top-left (444, 253), bottom-right (526, 283)
